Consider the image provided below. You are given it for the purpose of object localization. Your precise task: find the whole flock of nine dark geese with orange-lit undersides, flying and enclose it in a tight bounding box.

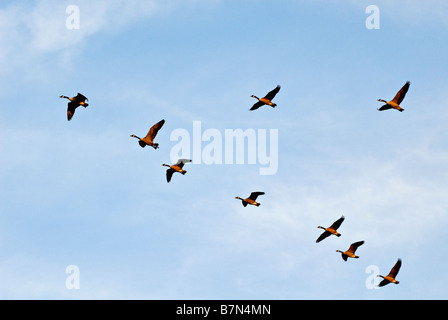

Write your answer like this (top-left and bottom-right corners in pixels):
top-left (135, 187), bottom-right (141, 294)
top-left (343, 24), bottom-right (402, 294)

top-left (60, 81), bottom-right (410, 287)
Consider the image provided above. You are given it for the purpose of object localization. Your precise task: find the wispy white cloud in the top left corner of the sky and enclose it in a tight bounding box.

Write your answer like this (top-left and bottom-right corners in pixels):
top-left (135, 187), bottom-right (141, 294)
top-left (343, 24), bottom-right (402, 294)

top-left (0, 0), bottom-right (182, 74)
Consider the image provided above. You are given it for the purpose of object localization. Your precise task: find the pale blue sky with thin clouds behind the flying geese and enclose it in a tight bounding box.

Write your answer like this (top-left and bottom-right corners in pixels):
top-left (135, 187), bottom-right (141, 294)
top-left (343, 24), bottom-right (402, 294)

top-left (0, 0), bottom-right (448, 300)
